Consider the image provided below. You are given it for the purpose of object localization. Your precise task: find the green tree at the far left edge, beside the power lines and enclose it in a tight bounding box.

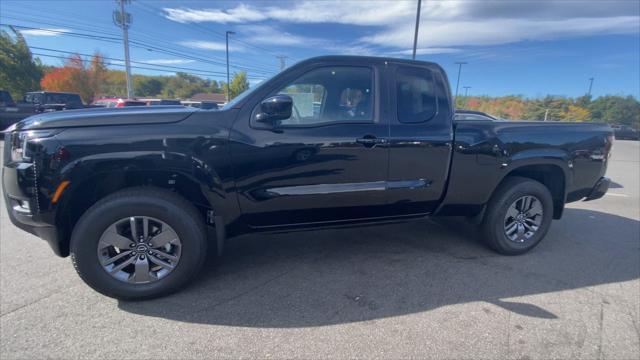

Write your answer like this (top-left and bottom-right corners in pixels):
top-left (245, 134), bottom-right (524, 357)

top-left (0, 29), bottom-right (42, 99)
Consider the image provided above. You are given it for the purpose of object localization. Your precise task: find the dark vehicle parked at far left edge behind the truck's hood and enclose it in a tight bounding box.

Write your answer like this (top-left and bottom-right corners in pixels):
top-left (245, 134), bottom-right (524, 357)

top-left (0, 91), bottom-right (84, 130)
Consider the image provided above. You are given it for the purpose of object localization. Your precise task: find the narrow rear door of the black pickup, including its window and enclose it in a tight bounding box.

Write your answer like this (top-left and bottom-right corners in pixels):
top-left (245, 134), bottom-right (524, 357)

top-left (388, 64), bottom-right (453, 215)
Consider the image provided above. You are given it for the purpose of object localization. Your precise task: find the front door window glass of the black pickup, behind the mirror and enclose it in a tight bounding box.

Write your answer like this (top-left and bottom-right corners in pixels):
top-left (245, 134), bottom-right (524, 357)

top-left (278, 66), bottom-right (373, 126)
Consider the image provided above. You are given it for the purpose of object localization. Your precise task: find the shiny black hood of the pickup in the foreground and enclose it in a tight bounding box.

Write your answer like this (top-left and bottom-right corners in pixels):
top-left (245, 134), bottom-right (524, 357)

top-left (5, 106), bottom-right (199, 131)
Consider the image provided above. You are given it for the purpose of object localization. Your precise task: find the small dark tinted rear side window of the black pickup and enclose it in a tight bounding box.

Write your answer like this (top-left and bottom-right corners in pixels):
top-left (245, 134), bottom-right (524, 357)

top-left (396, 68), bottom-right (438, 123)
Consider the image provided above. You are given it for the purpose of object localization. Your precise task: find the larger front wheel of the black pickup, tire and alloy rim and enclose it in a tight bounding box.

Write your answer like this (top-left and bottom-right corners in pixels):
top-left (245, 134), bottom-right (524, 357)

top-left (71, 188), bottom-right (207, 300)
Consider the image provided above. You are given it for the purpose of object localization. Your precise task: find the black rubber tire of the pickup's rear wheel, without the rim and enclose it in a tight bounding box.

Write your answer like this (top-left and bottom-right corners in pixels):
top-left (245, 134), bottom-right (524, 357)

top-left (482, 177), bottom-right (553, 255)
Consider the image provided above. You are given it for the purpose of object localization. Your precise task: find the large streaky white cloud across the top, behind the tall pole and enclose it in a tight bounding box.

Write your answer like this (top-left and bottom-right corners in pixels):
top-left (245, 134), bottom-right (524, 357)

top-left (164, 0), bottom-right (640, 54)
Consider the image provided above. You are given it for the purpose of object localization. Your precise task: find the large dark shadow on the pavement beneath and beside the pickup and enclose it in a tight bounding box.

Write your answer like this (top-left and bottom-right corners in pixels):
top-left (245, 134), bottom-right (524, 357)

top-left (119, 208), bottom-right (640, 328)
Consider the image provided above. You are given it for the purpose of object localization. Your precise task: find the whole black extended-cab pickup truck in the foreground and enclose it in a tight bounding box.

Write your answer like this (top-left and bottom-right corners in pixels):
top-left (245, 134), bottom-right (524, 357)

top-left (2, 56), bottom-right (613, 299)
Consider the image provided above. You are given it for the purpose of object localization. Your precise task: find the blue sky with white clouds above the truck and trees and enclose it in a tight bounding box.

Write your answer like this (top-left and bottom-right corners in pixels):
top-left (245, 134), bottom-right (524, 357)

top-left (0, 0), bottom-right (640, 98)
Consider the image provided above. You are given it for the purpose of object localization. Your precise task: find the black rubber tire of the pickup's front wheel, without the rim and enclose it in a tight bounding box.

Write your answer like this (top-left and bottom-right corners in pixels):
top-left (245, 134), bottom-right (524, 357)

top-left (71, 187), bottom-right (207, 300)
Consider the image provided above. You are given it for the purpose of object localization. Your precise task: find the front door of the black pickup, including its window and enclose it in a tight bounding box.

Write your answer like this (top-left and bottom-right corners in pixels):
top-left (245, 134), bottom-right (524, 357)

top-left (231, 65), bottom-right (389, 227)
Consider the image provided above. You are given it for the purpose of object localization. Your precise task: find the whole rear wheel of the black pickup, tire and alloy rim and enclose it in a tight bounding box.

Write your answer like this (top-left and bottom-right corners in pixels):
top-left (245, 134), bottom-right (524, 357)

top-left (482, 177), bottom-right (553, 255)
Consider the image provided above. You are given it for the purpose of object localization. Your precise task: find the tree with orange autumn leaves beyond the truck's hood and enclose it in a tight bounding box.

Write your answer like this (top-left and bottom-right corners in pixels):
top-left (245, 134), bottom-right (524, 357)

top-left (40, 52), bottom-right (108, 103)
